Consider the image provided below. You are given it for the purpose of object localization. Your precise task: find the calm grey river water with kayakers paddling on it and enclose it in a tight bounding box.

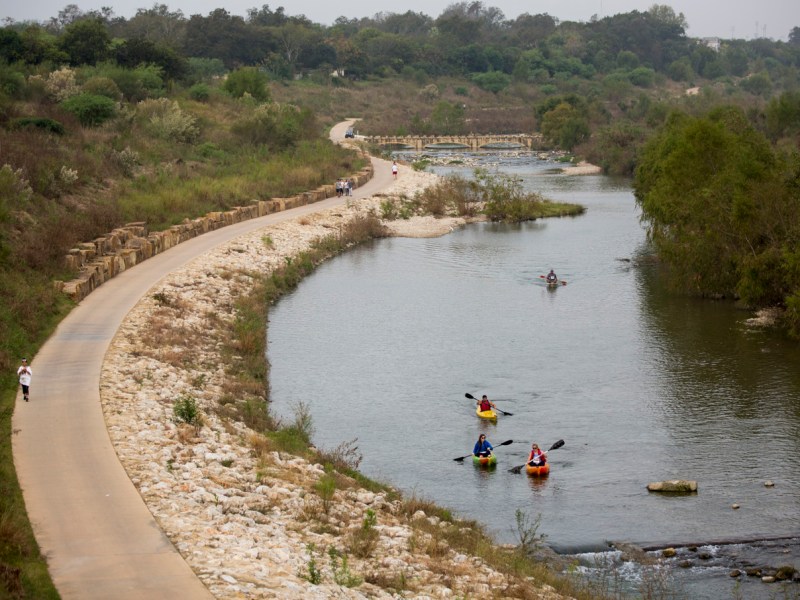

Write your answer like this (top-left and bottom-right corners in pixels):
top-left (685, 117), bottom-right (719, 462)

top-left (268, 155), bottom-right (800, 599)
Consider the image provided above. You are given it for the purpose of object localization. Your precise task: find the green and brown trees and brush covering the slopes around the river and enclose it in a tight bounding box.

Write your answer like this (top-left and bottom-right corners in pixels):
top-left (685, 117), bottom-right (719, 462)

top-left (0, 2), bottom-right (800, 598)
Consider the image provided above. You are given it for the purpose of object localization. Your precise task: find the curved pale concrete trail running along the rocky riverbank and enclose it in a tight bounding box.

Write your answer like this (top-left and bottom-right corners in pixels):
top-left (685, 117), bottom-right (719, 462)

top-left (13, 120), bottom-right (392, 600)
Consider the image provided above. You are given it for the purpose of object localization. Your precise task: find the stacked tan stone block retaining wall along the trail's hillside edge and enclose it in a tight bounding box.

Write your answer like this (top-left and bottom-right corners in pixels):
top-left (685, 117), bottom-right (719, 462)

top-left (61, 163), bottom-right (373, 302)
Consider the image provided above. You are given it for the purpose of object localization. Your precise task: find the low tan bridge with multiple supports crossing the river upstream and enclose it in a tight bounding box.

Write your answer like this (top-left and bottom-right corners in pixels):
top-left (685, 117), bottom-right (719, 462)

top-left (359, 133), bottom-right (544, 150)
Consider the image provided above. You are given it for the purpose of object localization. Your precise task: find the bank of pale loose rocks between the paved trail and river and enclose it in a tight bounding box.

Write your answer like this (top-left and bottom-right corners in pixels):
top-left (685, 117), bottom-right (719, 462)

top-left (101, 169), bottom-right (576, 600)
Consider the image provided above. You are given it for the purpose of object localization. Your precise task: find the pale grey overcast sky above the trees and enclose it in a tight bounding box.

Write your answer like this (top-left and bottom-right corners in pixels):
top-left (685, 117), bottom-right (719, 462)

top-left (0, 0), bottom-right (800, 41)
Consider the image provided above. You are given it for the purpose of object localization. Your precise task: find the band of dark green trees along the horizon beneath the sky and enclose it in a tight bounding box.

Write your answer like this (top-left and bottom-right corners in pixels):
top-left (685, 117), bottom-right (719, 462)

top-left (0, 1), bottom-right (800, 90)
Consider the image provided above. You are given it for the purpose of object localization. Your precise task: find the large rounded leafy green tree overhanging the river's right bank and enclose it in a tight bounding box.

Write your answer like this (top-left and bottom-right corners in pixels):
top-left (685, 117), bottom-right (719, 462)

top-left (634, 107), bottom-right (800, 307)
